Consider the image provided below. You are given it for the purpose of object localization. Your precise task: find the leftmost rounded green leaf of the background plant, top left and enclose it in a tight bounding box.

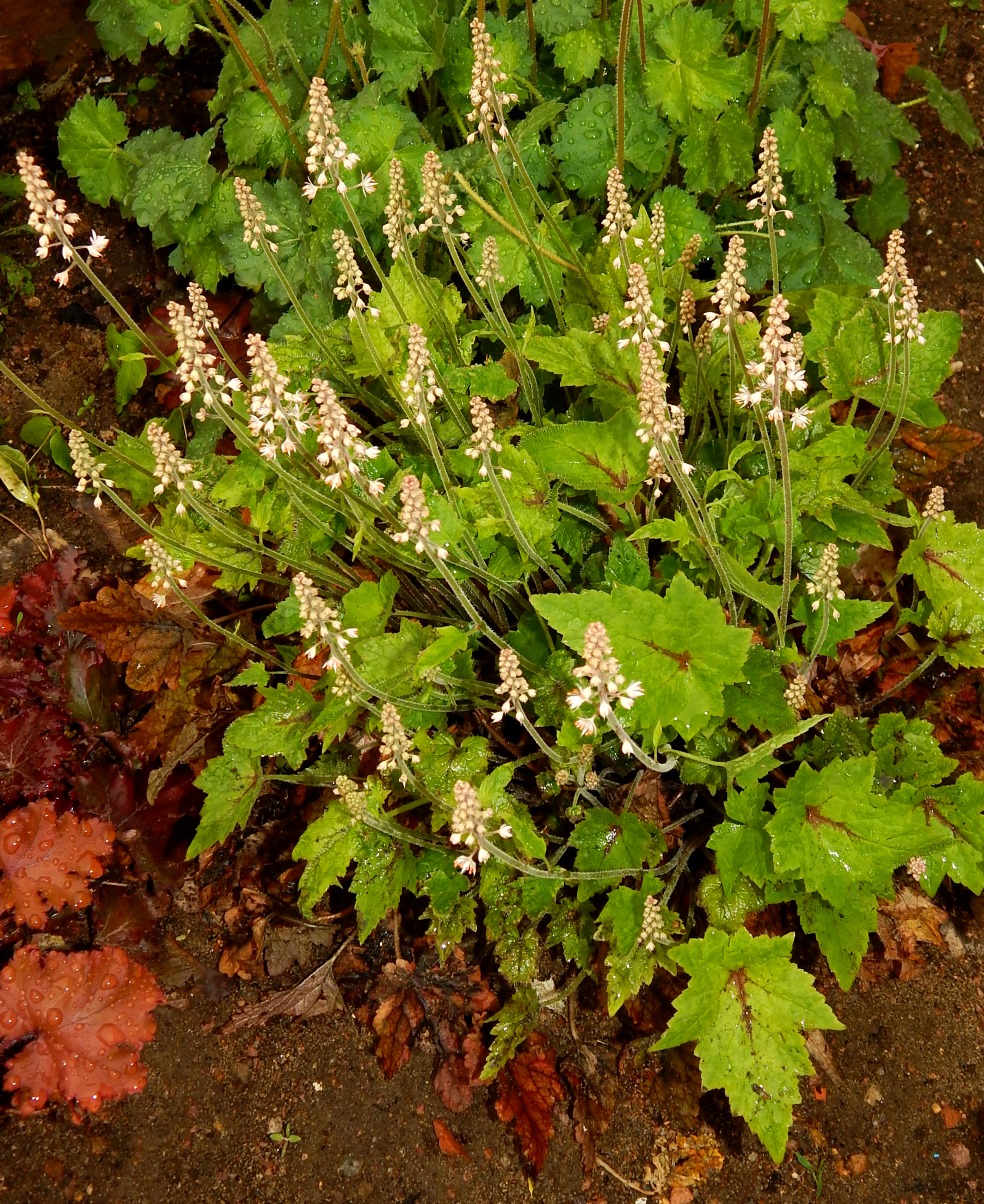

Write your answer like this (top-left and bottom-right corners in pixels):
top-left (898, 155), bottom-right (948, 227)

top-left (58, 96), bottom-right (134, 205)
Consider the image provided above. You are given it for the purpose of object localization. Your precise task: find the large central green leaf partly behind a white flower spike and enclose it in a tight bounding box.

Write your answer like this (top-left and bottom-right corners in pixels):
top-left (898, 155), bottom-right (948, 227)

top-left (534, 573), bottom-right (752, 737)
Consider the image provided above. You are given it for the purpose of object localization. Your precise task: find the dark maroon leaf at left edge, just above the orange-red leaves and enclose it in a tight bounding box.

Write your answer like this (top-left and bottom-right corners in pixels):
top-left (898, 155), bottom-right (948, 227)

top-left (0, 707), bottom-right (75, 803)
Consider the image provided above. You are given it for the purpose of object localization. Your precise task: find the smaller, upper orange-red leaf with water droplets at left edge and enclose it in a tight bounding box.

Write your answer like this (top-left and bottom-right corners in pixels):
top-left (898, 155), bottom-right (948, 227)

top-left (0, 799), bottom-right (116, 929)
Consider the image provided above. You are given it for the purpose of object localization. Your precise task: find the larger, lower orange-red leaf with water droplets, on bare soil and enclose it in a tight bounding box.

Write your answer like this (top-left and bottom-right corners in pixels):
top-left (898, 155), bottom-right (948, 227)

top-left (0, 946), bottom-right (164, 1121)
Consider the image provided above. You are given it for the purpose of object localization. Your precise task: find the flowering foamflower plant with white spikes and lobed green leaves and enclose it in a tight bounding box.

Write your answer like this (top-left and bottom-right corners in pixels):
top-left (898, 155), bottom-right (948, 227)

top-left (2, 6), bottom-right (984, 1158)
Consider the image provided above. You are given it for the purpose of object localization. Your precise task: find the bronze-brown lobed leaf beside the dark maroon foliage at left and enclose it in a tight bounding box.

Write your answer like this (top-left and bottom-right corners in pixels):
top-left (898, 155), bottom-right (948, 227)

top-left (61, 582), bottom-right (230, 691)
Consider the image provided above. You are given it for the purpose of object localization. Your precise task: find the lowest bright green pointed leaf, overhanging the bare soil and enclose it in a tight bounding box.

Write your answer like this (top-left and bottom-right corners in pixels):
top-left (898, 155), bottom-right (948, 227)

top-left (654, 928), bottom-right (843, 1163)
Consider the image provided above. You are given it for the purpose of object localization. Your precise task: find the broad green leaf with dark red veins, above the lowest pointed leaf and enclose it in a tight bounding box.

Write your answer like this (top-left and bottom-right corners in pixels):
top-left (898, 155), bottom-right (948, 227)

top-left (766, 756), bottom-right (932, 908)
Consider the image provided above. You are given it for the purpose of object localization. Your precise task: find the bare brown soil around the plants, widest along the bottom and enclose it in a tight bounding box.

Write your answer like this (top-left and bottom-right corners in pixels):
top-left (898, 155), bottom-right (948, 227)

top-left (0, 0), bottom-right (984, 1204)
